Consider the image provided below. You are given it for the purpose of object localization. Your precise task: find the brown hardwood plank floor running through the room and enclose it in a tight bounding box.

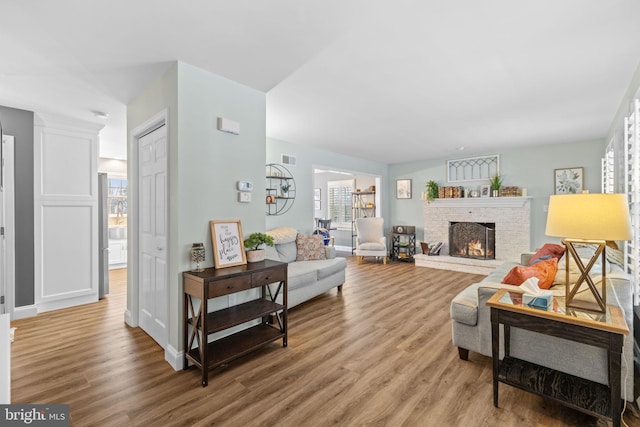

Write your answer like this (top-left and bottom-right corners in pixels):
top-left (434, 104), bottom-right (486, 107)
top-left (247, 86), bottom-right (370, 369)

top-left (12, 258), bottom-right (640, 426)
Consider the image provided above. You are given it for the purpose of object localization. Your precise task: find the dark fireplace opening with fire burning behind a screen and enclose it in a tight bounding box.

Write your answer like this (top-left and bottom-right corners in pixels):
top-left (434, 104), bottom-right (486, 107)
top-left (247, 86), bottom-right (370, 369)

top-left (449, 222), bottom-right (496, 259)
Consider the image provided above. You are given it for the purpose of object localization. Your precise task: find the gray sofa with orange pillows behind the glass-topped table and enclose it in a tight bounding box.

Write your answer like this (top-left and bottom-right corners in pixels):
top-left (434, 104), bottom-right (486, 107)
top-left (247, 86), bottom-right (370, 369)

top-left (450, 251), bottom-right (634, 401)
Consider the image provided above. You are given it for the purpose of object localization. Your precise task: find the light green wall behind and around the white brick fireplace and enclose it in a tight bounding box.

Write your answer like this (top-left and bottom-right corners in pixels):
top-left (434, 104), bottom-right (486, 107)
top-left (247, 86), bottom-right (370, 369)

top-left (388, 140), bottom-right (606, 249)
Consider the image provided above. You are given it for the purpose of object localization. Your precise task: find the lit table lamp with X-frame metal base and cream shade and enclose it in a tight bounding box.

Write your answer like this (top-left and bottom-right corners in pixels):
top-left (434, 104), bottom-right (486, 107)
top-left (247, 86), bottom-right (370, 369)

top-left (545, 194), bottom-right (631, 313)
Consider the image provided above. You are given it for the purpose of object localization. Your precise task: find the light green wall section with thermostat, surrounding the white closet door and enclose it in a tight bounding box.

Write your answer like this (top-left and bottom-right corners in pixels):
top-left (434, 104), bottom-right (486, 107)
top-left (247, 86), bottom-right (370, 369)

top-left (128, 62), bottom-right (266, 358)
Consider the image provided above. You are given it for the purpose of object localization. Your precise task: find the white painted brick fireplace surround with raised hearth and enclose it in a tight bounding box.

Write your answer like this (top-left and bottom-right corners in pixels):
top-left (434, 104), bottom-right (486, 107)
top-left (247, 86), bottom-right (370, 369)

top-left (415, 197), bottom-right (531, 274)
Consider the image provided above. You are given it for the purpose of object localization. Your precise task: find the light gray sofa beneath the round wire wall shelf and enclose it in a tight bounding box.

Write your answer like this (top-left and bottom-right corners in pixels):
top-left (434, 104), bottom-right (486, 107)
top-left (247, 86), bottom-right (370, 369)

top-left (266, 227), bottom-right (347, 308)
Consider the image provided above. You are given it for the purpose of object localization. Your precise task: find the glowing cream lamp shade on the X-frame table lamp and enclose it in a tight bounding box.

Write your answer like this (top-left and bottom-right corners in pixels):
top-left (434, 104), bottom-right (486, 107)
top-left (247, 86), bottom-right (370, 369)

top-left (545, 194), bottom-right (631, 240)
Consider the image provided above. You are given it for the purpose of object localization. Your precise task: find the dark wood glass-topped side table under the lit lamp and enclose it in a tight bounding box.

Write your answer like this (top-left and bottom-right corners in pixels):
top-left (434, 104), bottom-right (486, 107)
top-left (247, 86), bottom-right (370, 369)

top-left (487, 289), bottom-right (629, 427)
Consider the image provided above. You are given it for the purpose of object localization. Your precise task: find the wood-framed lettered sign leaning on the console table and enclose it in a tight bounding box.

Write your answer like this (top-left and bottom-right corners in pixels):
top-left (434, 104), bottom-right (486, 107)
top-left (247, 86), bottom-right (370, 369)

top-left (209, 219), bottom-right (247, 268)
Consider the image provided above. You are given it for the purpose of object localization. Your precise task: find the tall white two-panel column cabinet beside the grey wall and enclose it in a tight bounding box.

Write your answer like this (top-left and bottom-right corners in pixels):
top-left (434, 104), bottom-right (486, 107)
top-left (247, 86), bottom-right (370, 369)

top-left (34, 114), bottom-right (102, 312)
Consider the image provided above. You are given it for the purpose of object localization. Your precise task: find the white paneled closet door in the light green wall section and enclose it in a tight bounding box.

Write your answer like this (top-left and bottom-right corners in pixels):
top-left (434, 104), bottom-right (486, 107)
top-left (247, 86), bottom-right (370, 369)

top-left (138, 126), bottom-right (169, 348)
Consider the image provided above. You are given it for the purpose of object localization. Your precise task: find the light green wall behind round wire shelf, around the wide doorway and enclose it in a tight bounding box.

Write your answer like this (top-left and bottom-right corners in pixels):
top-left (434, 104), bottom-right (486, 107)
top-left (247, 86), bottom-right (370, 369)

top-left (266, 139), bottom-right (388, 233)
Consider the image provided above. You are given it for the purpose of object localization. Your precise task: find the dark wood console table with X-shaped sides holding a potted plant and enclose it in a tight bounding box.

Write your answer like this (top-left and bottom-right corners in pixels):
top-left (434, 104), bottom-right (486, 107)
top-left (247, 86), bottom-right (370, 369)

top-left (182, 260), bottom-right (287, 387)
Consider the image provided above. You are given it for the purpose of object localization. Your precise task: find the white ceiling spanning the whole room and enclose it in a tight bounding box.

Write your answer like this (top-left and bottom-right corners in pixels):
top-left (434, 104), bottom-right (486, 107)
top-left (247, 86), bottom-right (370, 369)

top-left (0, 0), bottom-right (640, 163)
